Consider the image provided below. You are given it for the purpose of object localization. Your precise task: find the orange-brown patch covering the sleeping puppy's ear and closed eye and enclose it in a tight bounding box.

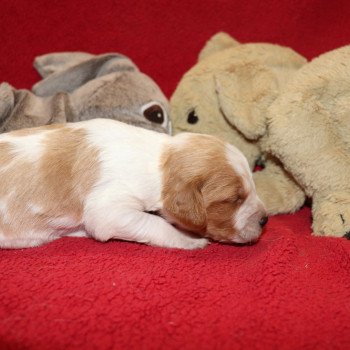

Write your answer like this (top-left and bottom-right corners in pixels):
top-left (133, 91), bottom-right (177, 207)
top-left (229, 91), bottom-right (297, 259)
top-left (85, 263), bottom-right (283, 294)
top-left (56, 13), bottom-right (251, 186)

top-left (162, 135), bottom-right (247, 240)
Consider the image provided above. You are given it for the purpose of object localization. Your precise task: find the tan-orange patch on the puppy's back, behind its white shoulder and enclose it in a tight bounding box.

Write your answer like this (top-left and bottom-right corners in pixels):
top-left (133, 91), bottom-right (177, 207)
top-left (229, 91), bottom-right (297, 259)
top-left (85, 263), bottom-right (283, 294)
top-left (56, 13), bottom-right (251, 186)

top-left (37, 128), bottom-right (98, 220)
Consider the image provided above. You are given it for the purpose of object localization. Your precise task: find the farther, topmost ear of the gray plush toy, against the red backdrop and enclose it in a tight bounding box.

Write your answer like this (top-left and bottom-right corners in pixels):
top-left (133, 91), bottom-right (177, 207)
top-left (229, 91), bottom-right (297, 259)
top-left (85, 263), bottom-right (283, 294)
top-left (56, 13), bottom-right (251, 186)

top-left (33, 52), bottom-right (94, 78)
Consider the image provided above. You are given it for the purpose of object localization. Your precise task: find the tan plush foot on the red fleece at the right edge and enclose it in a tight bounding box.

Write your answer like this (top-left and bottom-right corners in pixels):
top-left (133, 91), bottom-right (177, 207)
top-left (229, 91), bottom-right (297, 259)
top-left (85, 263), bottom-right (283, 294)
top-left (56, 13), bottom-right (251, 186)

top-left (312, 194), bottom-right (350, 239)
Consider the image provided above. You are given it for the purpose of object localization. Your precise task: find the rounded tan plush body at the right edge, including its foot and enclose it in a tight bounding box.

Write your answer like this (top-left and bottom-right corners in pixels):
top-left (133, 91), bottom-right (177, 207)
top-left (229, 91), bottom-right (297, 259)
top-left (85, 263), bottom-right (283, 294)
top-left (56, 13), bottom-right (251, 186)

top-left (262, 45), bottom-right (350, 239)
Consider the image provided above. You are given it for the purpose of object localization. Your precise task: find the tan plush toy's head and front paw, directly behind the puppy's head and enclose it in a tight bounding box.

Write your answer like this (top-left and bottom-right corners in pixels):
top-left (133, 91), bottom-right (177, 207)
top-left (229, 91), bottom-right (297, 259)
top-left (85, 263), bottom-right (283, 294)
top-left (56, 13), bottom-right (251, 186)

top-left (171, 33), bottom-right (306, 214)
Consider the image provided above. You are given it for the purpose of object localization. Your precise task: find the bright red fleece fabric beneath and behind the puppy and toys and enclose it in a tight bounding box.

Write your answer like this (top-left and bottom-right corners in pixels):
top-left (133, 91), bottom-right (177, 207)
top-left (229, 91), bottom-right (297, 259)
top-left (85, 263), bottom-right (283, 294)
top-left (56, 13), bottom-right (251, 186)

top-left (0, 0), bottom-right (350, 349)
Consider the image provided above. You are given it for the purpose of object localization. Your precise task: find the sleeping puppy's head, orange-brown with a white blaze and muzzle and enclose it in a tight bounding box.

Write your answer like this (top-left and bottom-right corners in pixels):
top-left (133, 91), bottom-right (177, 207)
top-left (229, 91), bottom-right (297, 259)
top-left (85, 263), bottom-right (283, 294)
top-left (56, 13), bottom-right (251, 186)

top-left (162, 134), bottom-right (267, 243)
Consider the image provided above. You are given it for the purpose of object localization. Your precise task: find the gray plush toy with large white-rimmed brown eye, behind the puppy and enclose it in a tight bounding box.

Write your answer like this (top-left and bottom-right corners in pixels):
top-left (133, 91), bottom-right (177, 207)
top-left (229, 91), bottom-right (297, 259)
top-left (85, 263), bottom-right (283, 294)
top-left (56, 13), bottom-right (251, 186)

top-left (0, 52), bottom-right (171, 133)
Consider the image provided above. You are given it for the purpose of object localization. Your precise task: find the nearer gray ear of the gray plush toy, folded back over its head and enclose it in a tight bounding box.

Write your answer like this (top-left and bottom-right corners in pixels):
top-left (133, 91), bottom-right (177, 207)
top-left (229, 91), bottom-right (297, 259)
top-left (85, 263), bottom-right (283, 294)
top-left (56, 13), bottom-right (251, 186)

top-left (32, 54), bottom-right (138, 96)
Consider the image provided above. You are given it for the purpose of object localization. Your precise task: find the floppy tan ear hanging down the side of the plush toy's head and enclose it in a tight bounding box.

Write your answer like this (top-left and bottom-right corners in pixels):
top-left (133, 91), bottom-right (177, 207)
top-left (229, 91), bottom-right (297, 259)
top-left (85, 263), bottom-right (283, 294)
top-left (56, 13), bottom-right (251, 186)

top-left (214, 63), bottom-right (278, 140)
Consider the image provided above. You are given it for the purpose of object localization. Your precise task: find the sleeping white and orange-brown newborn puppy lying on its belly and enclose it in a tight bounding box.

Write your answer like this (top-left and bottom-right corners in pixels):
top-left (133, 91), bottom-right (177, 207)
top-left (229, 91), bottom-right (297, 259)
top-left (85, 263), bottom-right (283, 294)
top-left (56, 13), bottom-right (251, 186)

top-left (0, 119), bottom-right (267, 249)
